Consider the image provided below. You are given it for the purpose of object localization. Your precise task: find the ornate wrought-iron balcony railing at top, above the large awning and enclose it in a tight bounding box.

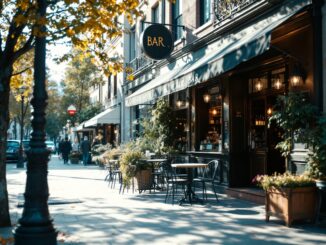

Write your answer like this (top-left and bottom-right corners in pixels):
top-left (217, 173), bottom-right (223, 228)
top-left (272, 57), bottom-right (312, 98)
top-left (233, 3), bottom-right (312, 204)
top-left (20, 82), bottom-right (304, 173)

top-left (214, 0), bottom-right (260, 21)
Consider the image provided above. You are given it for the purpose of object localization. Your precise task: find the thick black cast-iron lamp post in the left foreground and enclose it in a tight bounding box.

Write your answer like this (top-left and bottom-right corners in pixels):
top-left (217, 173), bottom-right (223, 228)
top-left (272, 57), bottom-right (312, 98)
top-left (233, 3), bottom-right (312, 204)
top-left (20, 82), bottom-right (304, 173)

top-left (14, 0), bottom-right (57, 245)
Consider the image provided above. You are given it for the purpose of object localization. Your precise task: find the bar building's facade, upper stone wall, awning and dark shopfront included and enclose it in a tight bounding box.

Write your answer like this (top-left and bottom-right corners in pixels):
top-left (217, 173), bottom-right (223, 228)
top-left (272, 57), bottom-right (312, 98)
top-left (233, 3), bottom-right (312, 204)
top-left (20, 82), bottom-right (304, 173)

top-left (125, 0), bottom-right (325, 186)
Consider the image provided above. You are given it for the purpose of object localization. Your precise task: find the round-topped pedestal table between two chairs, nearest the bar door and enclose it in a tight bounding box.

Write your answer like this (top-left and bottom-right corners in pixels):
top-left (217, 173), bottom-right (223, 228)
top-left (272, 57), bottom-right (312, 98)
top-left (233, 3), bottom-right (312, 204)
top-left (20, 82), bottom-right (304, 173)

top-left (171, 163), bottom-right (208, 205)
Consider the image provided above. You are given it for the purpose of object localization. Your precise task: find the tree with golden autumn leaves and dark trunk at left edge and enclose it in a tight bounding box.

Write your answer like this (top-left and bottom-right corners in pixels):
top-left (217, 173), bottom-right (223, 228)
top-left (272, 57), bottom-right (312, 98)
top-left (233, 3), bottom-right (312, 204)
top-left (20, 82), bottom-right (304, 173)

top-left (0, 0), bottom-right (140, 227)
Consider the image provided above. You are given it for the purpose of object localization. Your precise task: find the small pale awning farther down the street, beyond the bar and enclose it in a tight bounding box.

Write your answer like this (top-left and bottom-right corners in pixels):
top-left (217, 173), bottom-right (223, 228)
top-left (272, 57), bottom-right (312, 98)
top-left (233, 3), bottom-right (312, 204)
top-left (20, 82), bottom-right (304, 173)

top-left (84, 107), bottom-right (120, 127)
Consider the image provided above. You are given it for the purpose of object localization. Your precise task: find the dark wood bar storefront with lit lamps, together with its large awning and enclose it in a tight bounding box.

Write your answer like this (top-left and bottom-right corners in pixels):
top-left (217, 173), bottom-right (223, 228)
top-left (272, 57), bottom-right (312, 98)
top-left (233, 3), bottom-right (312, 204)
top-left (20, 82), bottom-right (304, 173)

top-left (126, 0), bottom-right (322, 186)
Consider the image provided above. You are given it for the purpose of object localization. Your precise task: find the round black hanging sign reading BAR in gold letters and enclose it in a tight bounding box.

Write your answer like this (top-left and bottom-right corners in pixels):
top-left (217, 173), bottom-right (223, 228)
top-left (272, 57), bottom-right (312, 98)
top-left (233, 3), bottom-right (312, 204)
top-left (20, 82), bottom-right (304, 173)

top-left (140, 24), bottom-right (174, 60)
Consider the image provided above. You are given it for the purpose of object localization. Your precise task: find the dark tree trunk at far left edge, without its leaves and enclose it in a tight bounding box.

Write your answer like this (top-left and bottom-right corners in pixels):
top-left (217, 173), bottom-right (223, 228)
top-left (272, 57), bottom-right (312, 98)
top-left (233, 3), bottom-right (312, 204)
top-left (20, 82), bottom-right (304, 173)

top-left (0, 67), bottom-right (11, 227)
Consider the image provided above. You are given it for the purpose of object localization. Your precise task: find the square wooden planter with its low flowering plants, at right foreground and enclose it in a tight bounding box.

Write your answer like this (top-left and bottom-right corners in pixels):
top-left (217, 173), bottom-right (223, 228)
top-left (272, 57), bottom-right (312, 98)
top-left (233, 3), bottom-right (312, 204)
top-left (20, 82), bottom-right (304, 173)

top-left (257, 172), bottom-right (317, 226)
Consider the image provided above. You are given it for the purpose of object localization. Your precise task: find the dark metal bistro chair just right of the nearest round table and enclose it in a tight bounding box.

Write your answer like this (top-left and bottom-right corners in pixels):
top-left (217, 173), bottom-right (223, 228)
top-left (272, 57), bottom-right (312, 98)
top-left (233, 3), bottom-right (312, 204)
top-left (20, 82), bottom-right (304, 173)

top-left (193, 160), bottom-right (220, 202)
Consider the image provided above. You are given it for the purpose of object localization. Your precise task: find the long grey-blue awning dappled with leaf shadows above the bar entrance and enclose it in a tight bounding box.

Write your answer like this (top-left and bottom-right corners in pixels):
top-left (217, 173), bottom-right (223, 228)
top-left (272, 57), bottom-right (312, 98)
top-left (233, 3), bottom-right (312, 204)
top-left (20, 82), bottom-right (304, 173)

top-left (126, 0), bottom-right (311, 106)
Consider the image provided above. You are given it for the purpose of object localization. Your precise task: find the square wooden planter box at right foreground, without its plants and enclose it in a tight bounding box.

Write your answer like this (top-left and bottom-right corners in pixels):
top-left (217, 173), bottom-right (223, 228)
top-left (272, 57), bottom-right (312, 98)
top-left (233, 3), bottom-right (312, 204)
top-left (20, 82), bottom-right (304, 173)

top-left (265, 187), bottom-right (317, 226)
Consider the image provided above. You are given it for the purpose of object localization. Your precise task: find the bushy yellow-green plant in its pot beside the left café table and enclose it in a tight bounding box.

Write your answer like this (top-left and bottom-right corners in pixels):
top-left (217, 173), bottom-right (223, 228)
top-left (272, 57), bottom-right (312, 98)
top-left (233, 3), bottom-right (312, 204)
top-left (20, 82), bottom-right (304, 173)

top-left (120, 150), bottom-right (153, 192)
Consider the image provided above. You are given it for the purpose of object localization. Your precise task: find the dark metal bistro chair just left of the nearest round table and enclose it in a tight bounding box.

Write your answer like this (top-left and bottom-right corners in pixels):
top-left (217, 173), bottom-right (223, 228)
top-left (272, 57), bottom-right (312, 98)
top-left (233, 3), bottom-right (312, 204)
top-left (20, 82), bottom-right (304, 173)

top-left (162, 161), bottom-right (188, 204)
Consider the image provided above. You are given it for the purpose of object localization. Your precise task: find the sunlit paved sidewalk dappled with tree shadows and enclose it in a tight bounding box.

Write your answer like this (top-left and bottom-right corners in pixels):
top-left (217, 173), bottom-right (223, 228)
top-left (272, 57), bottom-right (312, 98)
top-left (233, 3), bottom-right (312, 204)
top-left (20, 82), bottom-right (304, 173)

top-left (0, 156), bottom-right (326, 245)
